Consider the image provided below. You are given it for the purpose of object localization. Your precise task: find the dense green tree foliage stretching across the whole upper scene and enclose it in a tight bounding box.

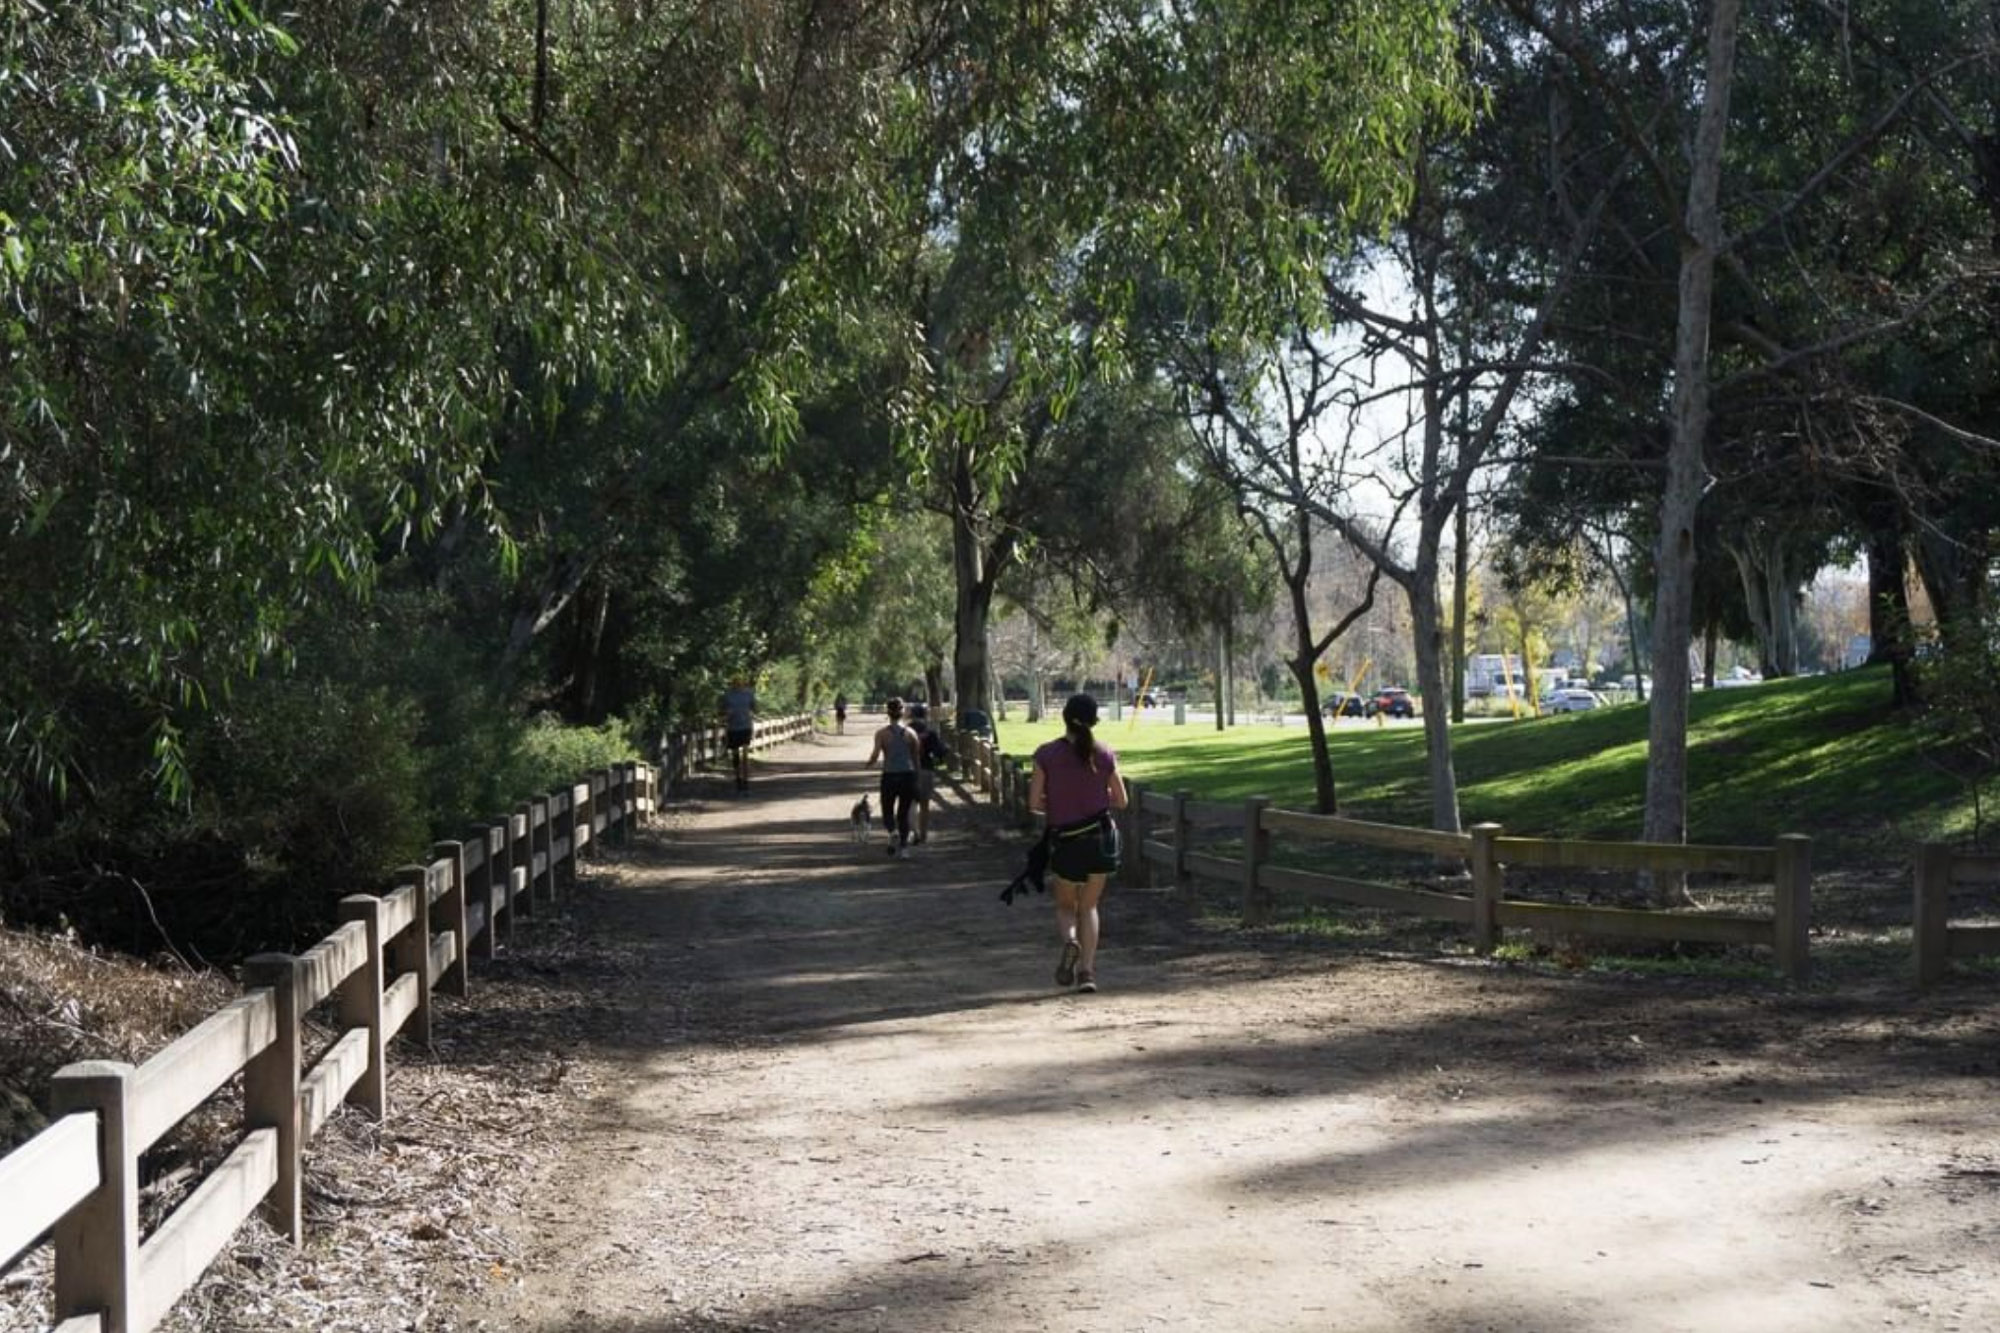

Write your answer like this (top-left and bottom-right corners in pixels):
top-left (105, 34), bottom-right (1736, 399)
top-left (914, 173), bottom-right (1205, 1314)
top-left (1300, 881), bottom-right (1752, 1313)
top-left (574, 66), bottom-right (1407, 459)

top-left (0, 0), bottom-right (2000, 947)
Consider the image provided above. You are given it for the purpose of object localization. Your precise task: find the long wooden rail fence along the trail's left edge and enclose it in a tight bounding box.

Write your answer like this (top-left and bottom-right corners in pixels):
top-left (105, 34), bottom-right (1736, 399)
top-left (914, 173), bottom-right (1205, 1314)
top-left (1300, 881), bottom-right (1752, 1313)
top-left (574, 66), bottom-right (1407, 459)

top-left (0, 717), bottom-right (812, 1333)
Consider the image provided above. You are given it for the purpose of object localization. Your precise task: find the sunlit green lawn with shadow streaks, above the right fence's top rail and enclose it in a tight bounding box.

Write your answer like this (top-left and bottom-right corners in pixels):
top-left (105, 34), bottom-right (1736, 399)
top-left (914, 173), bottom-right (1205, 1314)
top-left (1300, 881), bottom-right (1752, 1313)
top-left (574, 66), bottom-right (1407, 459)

top-left (1048, 671), bottom-right (1972, 869)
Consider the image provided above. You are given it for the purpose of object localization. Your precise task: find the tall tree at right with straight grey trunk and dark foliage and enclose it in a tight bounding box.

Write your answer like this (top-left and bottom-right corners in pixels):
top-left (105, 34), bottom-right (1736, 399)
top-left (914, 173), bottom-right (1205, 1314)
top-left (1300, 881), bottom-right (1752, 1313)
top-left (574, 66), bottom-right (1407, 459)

top-left (1502, 0), bottom-right (1994, 841)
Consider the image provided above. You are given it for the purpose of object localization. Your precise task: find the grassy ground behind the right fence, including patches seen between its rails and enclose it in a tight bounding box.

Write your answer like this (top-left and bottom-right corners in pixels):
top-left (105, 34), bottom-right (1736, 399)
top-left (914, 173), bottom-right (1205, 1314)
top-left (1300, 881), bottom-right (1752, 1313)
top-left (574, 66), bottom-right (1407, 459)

top-left (1106, 667), bottom-right (1994, 987)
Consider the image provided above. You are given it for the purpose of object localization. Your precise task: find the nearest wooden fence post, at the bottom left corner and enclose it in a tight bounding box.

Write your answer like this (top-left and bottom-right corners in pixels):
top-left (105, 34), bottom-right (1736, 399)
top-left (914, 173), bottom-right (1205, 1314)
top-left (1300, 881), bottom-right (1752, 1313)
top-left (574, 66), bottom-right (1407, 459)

top-left (50, 1061), bottom-right (138, 1333)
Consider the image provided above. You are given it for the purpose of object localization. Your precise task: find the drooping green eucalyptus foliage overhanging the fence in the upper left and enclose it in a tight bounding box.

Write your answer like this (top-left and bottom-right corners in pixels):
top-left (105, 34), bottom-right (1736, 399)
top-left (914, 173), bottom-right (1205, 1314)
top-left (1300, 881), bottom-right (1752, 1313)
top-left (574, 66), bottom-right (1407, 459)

top-left (0, 0), bottom-right (944, 819)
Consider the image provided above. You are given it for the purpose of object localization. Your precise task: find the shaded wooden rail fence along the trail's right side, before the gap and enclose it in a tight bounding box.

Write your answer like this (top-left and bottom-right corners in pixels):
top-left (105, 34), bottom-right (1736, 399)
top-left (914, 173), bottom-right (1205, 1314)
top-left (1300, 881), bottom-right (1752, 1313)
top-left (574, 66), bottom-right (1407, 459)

top-left (952, 720), bottom-right (1812, 981)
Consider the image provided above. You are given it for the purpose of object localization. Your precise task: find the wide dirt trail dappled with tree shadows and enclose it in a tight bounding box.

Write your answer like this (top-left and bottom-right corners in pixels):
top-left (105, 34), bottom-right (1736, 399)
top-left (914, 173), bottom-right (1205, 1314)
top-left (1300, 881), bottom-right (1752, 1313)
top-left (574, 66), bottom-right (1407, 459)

top-left (466, 727), bottom-right (2000, 1333)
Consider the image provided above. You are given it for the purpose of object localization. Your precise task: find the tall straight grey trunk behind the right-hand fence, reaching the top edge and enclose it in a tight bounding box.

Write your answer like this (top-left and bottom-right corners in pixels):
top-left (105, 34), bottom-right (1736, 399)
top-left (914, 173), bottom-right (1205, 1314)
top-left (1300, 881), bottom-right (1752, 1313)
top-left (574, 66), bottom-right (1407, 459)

top-left (1644, 0), bottom-right (1742, 872)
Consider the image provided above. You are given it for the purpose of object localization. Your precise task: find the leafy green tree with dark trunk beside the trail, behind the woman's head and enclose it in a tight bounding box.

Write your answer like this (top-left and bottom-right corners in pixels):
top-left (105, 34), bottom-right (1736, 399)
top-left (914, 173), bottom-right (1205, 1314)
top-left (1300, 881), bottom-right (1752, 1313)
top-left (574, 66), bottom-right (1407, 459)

top-left (890, 0), bottom-right (1458, 707)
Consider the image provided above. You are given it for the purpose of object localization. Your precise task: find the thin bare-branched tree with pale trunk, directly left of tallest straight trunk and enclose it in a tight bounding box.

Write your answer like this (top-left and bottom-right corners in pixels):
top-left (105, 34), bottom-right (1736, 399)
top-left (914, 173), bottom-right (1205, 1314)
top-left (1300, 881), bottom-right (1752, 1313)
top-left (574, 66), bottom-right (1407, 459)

top-left (1180, 0), bottom-right (1632, 831)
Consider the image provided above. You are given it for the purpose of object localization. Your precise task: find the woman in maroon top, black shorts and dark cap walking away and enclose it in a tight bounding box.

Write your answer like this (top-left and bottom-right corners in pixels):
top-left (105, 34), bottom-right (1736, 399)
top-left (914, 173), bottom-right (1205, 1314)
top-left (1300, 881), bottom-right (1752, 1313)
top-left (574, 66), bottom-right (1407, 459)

top-left (1028, 695), bottom-right (1126, 991)
